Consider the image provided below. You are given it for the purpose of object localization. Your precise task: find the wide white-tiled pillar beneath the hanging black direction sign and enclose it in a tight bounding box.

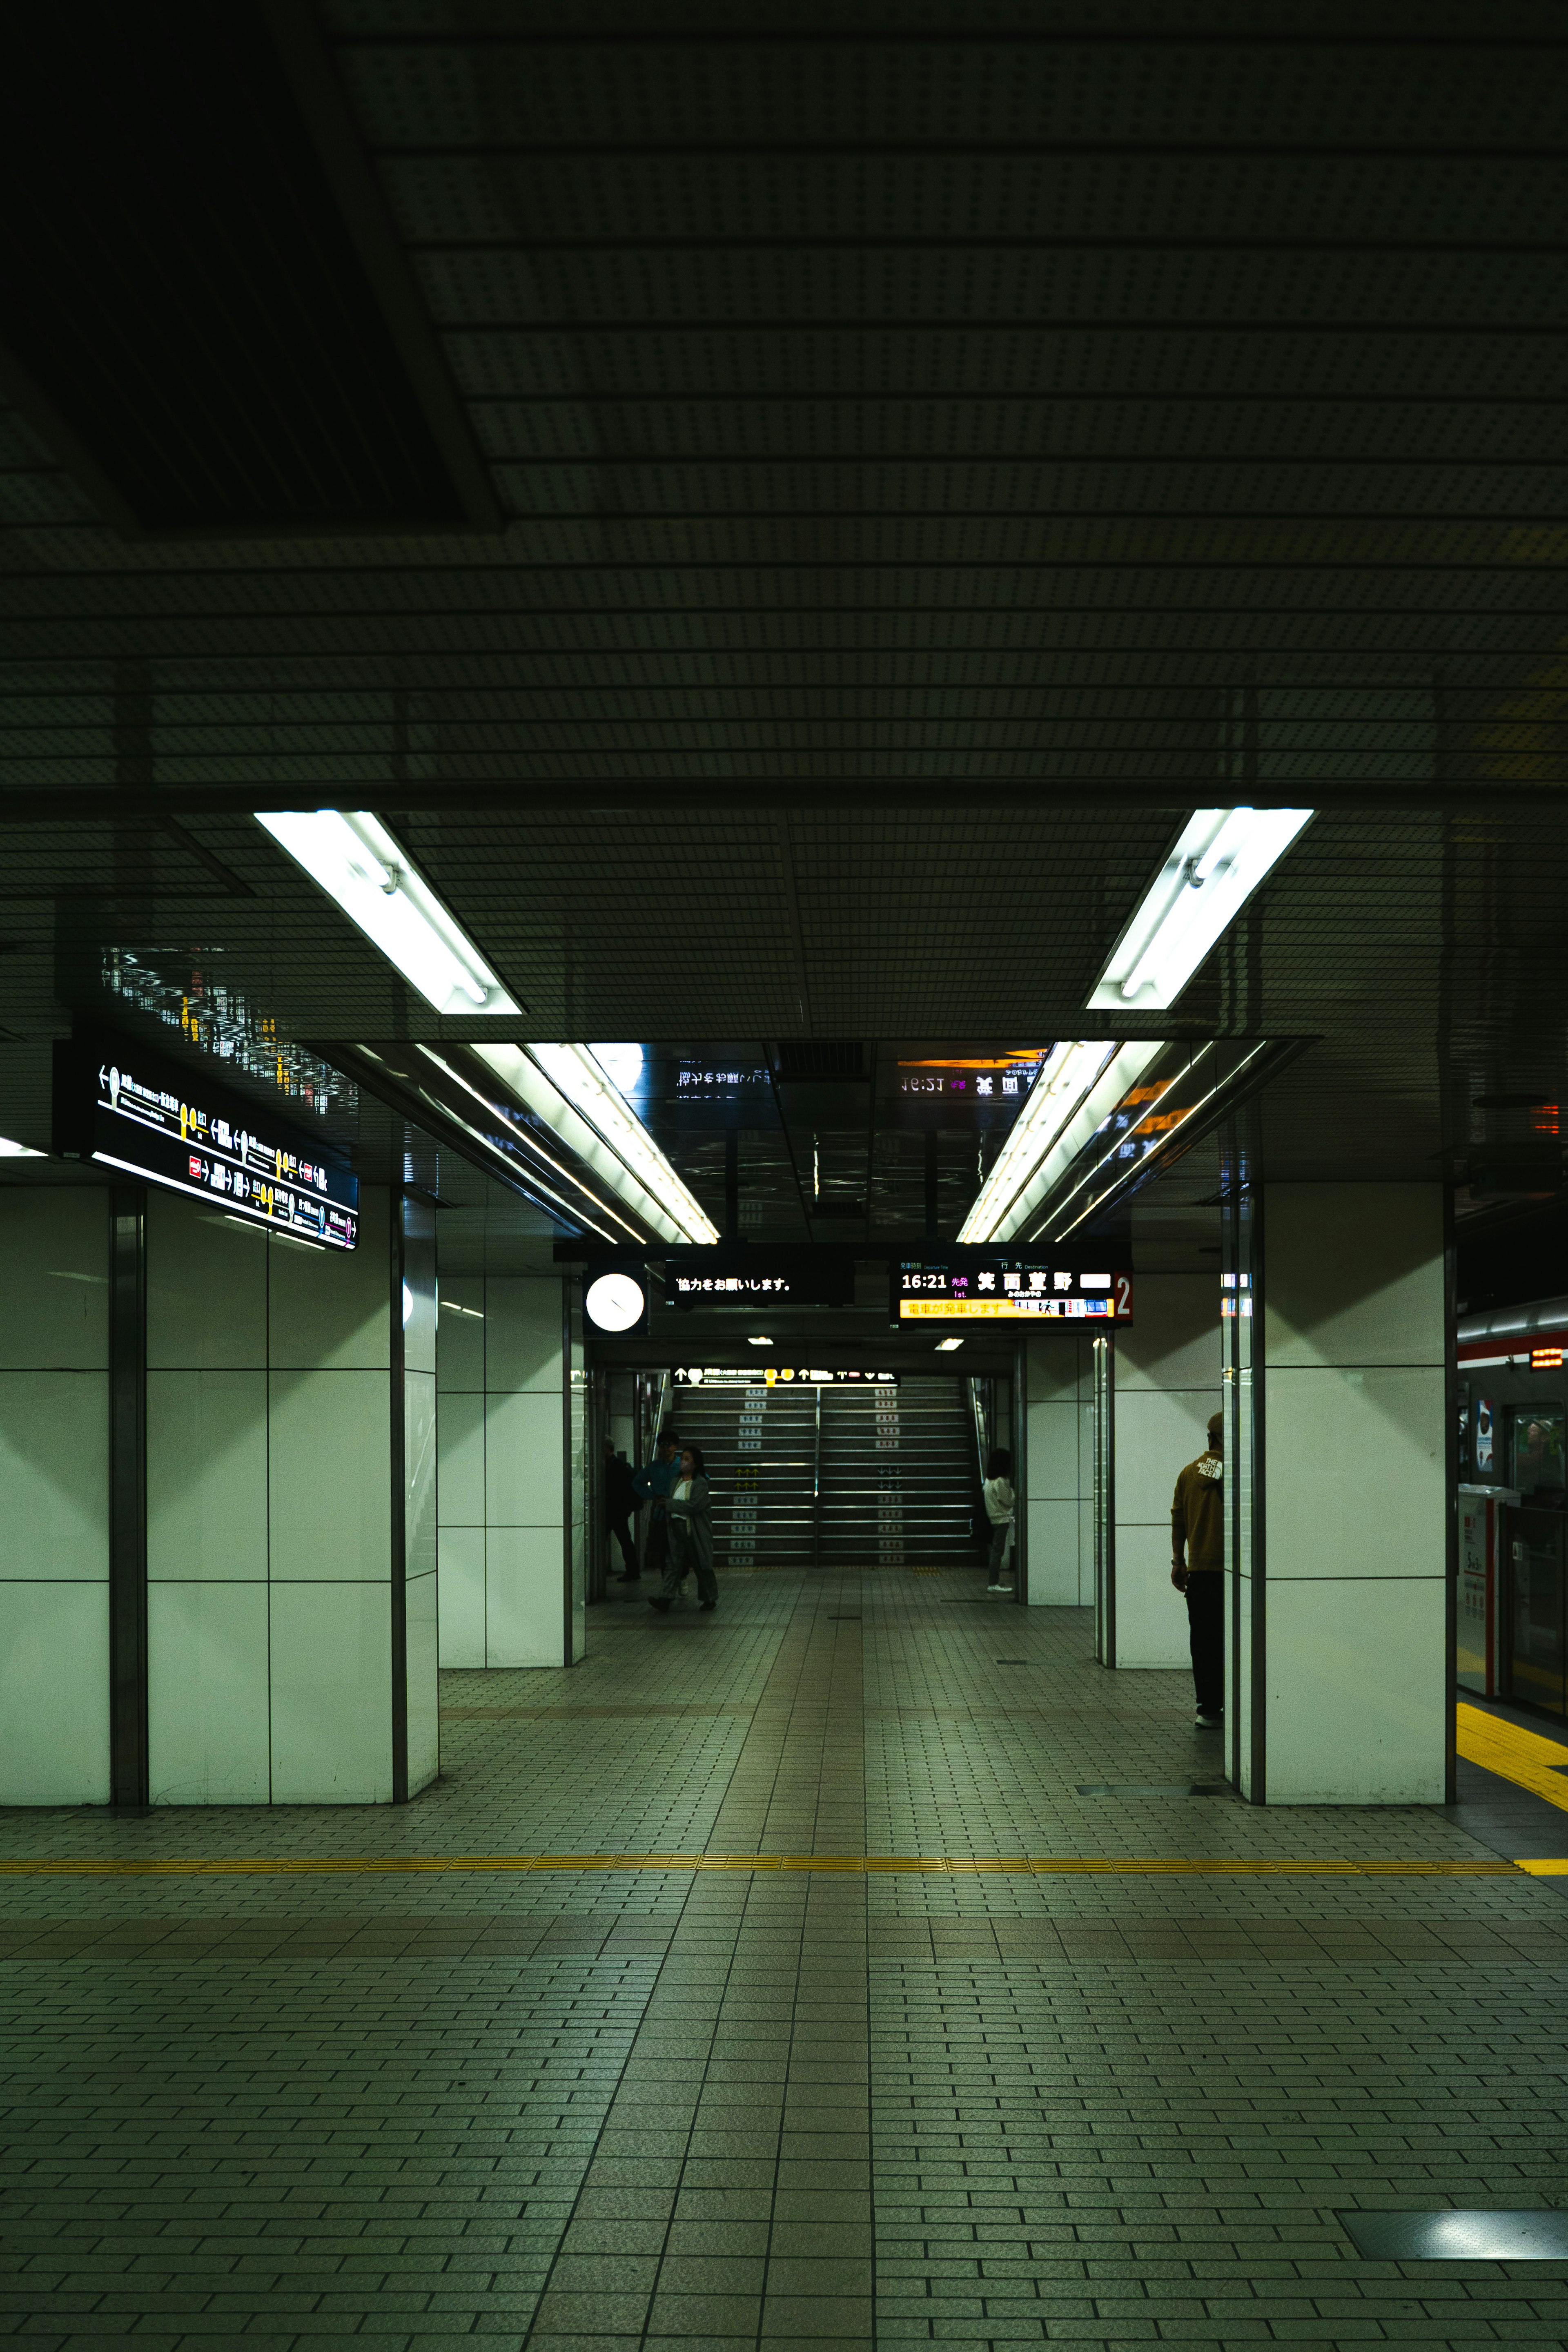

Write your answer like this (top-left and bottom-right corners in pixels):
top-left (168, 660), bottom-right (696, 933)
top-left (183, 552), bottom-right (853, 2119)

top-left (148, 1188), bottom-right (437, 1804)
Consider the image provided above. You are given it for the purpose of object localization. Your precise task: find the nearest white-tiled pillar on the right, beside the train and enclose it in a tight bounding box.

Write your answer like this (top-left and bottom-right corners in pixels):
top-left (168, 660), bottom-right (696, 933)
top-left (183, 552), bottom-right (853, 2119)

top-left (1227, 1183), bottom-right (1450, 1804)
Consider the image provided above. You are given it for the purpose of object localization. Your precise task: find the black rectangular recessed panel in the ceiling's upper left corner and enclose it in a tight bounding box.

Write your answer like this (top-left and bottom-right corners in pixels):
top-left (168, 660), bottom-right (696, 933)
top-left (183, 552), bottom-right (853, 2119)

top-left (0, 0), bottom-right (493, 534)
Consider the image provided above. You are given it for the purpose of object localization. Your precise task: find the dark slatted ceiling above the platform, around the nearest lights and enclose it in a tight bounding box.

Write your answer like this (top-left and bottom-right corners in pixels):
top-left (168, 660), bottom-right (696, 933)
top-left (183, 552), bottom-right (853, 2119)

top-left (0, 0), bottom-right (1568, 1230)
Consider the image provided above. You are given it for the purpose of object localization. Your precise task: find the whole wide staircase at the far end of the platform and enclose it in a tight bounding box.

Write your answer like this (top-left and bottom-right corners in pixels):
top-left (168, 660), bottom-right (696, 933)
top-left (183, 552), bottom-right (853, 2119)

top-left (675, 1378), bottom-right (985, 1569)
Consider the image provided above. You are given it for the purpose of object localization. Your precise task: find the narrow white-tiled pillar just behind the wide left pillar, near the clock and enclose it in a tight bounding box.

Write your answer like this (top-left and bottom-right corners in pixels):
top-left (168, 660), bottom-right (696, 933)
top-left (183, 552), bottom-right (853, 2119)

top-left (437, 1275), bottom-right (571, 1665)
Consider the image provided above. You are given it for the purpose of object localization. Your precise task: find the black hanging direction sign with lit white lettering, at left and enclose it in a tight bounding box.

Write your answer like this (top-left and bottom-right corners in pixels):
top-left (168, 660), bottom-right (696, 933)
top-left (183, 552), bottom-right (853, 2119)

top-left (54, 1037), bottom-right (360, 1249)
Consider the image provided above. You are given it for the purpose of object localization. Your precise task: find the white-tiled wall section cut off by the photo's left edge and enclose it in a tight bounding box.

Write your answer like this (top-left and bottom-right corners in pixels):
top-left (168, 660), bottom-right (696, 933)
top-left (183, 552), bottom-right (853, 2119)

top-left (0, 1186), bottom-right (111, 1804)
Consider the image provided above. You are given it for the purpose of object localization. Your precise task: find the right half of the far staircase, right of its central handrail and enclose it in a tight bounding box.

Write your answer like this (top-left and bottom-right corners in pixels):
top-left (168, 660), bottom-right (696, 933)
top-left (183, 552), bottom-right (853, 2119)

top-left (818, 1378), bottom-right (985, 1569)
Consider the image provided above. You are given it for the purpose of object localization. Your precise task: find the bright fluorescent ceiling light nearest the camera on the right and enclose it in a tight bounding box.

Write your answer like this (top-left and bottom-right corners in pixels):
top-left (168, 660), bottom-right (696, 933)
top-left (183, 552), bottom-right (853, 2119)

top-left (1089, 809), bottom-right (1314, 1014)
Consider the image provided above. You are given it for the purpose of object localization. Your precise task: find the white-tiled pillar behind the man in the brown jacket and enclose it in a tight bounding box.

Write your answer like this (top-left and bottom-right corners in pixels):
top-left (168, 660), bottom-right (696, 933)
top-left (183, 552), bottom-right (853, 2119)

top-left (1107, 1273), bottom-right (1220, 1665)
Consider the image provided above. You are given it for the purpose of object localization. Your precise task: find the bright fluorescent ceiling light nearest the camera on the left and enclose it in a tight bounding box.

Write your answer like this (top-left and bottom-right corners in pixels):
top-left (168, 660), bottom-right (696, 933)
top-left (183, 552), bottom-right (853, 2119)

top-left (256, 809), bottom-right (517, 1016)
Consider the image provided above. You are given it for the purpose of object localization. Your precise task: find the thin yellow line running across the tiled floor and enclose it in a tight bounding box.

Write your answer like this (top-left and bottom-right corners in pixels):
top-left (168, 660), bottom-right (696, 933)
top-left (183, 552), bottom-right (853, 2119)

top-left (0, 1853), bottom-right (1532, 1879)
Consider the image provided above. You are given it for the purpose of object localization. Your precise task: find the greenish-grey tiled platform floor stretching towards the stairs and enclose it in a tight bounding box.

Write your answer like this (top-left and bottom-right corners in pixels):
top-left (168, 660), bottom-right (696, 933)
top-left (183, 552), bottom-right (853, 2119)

top-left (0, 1571), bottom-right (1568, 2352)
